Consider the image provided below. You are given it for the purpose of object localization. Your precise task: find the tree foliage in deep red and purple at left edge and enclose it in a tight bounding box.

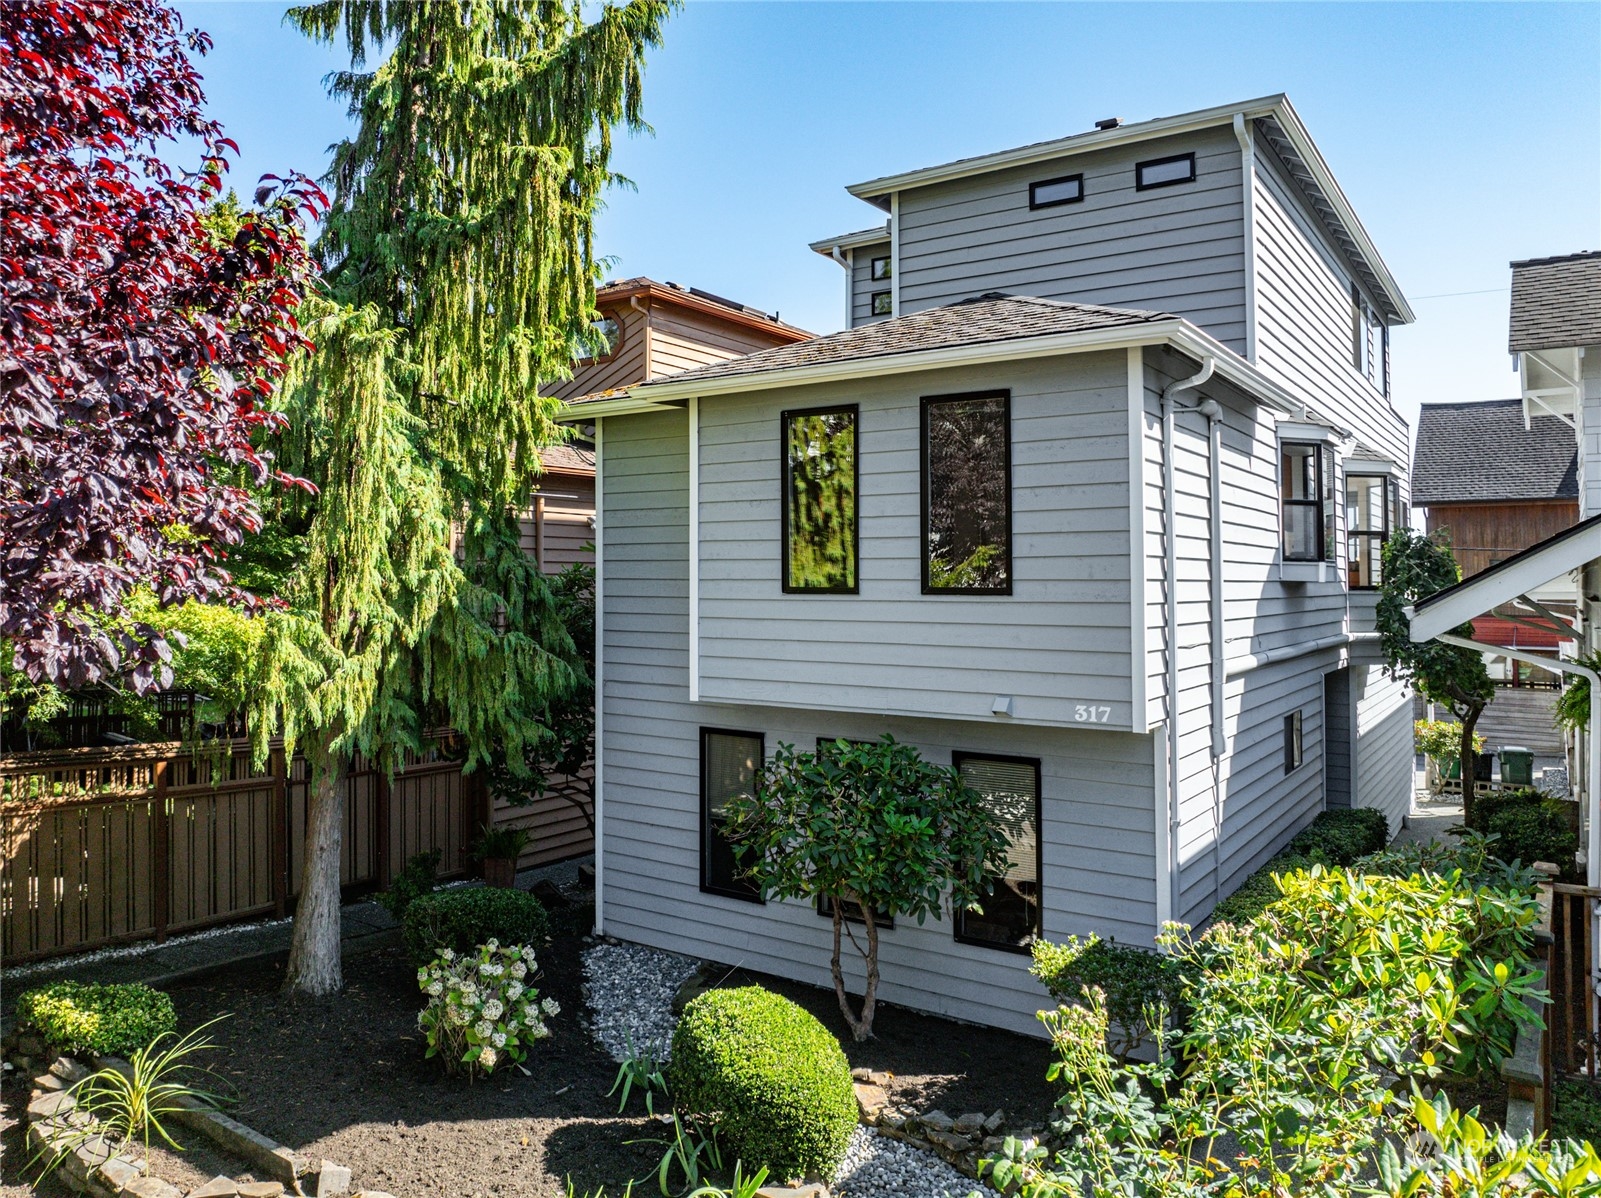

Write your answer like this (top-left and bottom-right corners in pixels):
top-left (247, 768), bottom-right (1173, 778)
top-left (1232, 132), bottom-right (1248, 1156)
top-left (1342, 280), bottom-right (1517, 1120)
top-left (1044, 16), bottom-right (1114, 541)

top-left (0, 0), bottom-right (325, 690)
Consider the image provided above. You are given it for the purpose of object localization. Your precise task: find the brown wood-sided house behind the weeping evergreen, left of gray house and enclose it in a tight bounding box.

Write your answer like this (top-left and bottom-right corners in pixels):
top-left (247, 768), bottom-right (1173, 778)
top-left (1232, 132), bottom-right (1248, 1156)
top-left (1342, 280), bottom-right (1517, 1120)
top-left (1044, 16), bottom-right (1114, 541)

top-left (493, 279), bottom-right (812, 868)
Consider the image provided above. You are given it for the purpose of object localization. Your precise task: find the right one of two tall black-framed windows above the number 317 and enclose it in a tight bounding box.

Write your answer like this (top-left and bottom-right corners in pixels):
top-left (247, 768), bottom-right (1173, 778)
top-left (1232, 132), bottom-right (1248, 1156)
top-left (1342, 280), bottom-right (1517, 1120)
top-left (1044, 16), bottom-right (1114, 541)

top-left (922, 391), bottom-right (1012, 594)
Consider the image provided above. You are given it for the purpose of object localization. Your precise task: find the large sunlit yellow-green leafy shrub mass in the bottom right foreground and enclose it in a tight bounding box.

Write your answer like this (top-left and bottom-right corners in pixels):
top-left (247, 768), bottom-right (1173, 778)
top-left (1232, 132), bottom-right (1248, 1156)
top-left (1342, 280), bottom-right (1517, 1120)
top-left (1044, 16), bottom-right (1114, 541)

top-left (988, 865), bottom-right (1549, 1198)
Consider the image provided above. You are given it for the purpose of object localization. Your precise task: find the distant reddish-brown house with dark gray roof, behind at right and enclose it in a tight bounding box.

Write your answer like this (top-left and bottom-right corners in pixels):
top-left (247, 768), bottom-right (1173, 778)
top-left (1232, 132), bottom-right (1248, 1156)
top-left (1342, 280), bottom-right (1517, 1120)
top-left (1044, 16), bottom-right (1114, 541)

top-left (1412, 399), bottom-right (1579, 682)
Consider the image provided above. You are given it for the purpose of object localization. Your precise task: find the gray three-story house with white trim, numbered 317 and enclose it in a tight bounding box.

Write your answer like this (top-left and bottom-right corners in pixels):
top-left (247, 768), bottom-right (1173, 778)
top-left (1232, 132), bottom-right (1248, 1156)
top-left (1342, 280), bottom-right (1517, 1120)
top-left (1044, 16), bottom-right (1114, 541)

top-left (573, 96), bottom-right (1412, 1033)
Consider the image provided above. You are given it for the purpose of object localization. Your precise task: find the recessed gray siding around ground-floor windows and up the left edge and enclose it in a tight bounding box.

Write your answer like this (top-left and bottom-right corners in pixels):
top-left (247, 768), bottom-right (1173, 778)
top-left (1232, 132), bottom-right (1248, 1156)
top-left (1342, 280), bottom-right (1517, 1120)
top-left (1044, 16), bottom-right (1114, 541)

top-left (602, 413), bottom-right (1154, 1035)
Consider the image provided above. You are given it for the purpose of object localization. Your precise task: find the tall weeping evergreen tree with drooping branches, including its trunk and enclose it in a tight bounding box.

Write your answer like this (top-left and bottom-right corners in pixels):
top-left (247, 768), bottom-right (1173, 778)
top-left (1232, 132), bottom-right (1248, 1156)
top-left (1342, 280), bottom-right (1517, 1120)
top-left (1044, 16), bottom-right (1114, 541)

top-left (251, 0), bottom-right (671, 995)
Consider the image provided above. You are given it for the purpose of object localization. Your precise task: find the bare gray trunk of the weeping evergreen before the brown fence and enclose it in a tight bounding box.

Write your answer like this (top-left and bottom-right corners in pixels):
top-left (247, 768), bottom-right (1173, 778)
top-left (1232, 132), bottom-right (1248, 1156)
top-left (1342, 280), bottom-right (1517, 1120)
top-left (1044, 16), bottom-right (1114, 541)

top-left (283, 746), bottom-right (344, 995)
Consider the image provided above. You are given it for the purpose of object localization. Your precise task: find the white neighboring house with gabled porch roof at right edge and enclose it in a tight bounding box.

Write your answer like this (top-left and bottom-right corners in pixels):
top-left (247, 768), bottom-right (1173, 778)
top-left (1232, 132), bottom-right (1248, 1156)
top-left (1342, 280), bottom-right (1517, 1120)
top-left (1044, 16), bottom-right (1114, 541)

top-left (1412, 253), bottom-right (1601, 887)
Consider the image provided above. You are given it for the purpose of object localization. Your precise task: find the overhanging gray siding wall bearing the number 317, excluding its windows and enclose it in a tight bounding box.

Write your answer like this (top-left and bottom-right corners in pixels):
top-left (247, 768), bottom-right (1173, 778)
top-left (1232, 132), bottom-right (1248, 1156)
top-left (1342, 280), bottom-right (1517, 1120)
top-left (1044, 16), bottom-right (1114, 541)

top-left (700, 351), bottom-right (1145, 732)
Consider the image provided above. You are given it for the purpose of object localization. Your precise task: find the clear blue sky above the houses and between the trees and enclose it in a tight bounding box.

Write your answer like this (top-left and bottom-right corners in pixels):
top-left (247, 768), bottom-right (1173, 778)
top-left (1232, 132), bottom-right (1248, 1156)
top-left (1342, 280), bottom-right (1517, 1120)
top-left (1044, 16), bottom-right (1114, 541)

top-left (179, 0), bottom-right (1601, 442)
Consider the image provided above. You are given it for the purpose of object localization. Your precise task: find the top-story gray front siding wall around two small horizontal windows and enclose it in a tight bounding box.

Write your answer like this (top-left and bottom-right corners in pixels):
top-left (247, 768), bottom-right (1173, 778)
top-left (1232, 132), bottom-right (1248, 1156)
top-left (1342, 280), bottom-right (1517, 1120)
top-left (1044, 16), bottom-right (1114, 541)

top-left (890, 128), bottom-right (1246, 352)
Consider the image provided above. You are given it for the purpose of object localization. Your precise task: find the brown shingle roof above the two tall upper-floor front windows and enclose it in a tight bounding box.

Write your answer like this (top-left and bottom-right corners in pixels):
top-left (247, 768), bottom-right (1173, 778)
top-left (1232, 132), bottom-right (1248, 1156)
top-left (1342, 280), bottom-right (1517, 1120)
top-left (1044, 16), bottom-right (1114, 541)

top-left (624, 291), bottom-right (1177, 392)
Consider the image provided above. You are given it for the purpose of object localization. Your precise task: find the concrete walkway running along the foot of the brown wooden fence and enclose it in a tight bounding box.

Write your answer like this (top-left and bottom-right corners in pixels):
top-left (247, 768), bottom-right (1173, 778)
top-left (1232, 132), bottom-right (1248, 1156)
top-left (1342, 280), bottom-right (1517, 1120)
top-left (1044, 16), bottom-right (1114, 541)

top-left (0, 857), bottom-right (592, 1028)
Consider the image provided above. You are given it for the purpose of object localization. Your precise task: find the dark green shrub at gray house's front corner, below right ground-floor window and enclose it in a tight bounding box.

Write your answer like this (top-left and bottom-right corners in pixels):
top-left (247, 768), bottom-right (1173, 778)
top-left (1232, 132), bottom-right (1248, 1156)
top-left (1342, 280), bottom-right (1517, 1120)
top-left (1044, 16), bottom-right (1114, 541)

top-left (1029, 935), bottom-right (1180, 1057)
